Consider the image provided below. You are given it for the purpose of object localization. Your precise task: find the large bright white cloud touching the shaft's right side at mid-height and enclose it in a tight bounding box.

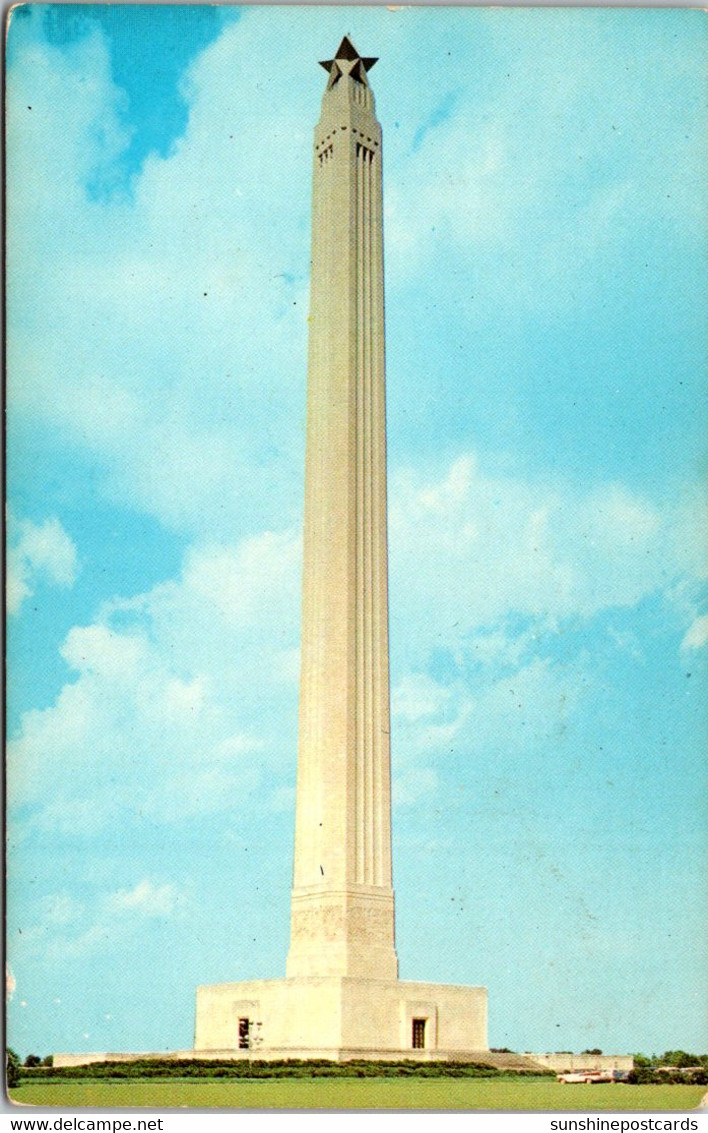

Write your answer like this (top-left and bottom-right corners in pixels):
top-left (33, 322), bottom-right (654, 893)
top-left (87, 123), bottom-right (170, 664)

top-left (390, 454), bottom-right (697, 653)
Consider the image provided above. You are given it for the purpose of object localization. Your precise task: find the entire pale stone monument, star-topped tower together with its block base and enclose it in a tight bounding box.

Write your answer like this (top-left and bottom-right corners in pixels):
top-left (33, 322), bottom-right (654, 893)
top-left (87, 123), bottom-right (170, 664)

top-left (195, 36), bottom-right (487, 1059)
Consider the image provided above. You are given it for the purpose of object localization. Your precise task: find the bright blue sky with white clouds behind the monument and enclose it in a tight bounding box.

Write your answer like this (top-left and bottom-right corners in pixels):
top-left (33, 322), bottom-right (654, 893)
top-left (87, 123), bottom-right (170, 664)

top-left (8, 6), bottom-right (708, 1054)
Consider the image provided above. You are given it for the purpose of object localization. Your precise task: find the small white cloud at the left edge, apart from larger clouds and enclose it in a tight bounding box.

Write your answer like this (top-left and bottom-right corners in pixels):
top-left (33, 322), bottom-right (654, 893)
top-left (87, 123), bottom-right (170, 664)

top-left (7, 517), bottom-right (78, 614)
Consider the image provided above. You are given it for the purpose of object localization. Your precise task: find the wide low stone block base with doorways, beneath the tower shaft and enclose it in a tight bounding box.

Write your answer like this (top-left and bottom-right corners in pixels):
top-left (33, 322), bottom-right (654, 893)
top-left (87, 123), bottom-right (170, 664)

top-left (195, 976), bottom-right (487, 1060)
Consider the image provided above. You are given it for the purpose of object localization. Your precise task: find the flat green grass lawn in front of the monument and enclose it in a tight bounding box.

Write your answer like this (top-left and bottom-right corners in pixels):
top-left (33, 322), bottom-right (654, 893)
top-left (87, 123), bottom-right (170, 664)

top-left (10, 1077), bottom-right (706, 1111)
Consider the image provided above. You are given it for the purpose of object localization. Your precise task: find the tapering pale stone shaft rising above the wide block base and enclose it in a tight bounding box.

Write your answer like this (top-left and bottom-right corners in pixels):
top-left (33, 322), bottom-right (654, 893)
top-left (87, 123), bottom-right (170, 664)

top-left (288, 41), bottom-right (398, 979)
